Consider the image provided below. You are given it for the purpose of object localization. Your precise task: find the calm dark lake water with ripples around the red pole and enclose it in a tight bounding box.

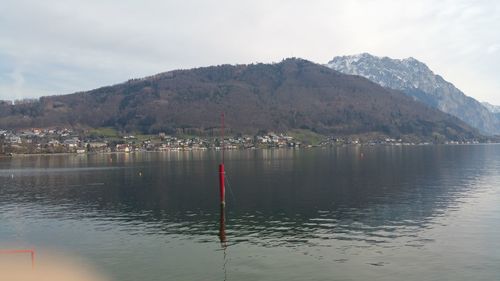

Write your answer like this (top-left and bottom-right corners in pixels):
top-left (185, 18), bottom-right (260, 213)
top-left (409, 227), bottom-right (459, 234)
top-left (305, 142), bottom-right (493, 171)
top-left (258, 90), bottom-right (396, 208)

top-left (0, 145), bottom-right (500, 281)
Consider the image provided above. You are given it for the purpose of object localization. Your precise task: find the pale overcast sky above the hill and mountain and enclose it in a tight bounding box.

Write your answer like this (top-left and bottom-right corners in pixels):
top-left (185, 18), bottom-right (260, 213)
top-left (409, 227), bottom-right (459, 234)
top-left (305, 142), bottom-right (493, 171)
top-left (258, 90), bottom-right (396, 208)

top-left (0, 0), bottom-right (500, 105)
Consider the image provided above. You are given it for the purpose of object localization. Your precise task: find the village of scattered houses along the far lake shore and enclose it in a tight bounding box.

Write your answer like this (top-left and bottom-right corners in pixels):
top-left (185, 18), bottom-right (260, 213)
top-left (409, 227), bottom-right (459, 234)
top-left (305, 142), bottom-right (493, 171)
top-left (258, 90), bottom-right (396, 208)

top-left (0, 128), bottom-right (484, 155)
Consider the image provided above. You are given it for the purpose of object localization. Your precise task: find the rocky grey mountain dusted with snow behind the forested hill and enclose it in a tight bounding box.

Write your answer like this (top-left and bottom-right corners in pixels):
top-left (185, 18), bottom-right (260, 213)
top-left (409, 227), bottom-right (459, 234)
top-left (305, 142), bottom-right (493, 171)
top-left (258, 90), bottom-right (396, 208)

top-left (327, 53), bottom-right (500, 135)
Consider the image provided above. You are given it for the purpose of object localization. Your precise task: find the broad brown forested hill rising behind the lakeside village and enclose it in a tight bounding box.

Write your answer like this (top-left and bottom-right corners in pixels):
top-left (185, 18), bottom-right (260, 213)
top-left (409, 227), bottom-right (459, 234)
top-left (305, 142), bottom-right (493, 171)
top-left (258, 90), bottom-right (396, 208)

top-left (0, 58), bottom-right (480, 140)
